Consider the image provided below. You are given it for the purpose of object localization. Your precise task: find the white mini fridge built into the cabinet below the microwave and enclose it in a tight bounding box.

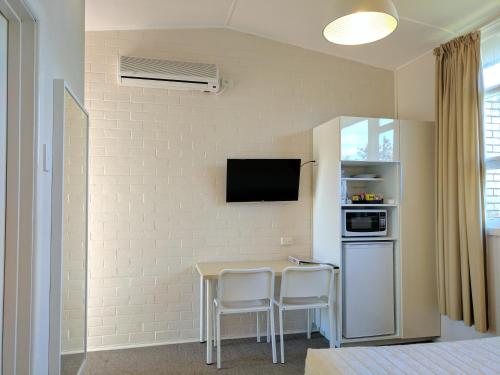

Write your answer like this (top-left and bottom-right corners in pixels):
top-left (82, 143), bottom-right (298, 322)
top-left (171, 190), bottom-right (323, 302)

top-left (342, 241), bottom-right (395, 339)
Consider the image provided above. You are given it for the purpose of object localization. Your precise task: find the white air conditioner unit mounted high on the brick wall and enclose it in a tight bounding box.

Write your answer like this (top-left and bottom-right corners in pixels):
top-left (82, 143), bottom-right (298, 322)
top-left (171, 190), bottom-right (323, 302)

top-left (118, 56), bottom-right (220, 92)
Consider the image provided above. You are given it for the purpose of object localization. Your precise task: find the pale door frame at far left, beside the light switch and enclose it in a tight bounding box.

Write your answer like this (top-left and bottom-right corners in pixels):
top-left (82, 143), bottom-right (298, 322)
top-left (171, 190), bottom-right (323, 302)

top-left (0, 0), bottom-right (38, 375)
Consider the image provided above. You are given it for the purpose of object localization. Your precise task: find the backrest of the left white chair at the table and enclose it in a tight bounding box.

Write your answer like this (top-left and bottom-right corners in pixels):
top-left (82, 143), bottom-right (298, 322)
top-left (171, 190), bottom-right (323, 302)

top-left (217, 268), bottom-right (274, 302)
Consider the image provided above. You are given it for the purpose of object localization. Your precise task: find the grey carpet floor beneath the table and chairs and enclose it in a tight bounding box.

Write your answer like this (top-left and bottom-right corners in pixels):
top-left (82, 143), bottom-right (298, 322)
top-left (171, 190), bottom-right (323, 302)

top-left (86, 334), bottom-right (328, 375)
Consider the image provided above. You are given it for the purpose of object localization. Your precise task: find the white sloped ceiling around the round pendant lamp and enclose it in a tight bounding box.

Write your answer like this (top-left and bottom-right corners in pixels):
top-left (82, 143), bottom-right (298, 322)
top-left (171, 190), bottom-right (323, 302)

top-left (86, 0), bottom-right (500, 69)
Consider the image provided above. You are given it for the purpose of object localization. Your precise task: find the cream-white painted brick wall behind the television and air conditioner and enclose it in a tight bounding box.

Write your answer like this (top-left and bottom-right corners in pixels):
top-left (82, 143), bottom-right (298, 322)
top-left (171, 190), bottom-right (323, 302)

top-left (86, 29), bottom-right (394, 349)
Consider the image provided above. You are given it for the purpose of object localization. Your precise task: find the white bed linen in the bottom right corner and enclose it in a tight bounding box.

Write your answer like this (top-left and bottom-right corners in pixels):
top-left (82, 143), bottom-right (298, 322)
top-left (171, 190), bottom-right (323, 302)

top-left (305, 337), bottom-right (500, 375)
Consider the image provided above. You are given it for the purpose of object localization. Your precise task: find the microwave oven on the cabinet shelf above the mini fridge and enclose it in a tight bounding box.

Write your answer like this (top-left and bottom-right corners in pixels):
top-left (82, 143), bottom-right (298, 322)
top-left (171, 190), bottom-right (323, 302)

top-left (342, 209), bottom-right (387, 237)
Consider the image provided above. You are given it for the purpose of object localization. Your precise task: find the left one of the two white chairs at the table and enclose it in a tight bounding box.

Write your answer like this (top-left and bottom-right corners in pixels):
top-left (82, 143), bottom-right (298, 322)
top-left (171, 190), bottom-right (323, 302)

top-left (214, 268), bottom-right (277, 368)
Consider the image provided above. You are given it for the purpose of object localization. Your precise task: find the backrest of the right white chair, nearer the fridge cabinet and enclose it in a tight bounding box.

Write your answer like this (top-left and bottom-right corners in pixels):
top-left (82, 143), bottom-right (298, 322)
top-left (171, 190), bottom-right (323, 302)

top-left (280, 265), bottom-right (333, 301)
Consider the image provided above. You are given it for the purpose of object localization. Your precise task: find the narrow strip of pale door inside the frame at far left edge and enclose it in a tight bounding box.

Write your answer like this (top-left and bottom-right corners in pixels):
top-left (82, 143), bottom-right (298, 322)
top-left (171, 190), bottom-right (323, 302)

top-left (0, 13), bottom-right (7, 369)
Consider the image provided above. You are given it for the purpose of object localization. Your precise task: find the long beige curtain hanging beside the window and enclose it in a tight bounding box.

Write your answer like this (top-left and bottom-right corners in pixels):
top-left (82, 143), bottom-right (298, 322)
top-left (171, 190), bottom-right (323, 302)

top-left (434, 32), bottom-right (488, 332)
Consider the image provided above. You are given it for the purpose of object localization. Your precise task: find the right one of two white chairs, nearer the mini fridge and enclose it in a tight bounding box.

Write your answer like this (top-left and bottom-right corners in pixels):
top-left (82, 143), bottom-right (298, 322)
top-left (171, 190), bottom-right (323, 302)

top-left (273, 265), bottom-right (336, 363)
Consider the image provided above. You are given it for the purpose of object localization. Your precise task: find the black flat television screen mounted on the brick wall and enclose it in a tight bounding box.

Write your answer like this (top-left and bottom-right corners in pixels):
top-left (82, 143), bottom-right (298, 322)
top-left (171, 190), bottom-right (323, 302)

top-left (226, 159), bottom-right (300, 202)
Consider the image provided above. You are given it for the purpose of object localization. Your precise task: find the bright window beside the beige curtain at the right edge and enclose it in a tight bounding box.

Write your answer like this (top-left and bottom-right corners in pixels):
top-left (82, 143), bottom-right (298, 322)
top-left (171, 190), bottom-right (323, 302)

top-left (481, 23), bottom-right (500, 228)
